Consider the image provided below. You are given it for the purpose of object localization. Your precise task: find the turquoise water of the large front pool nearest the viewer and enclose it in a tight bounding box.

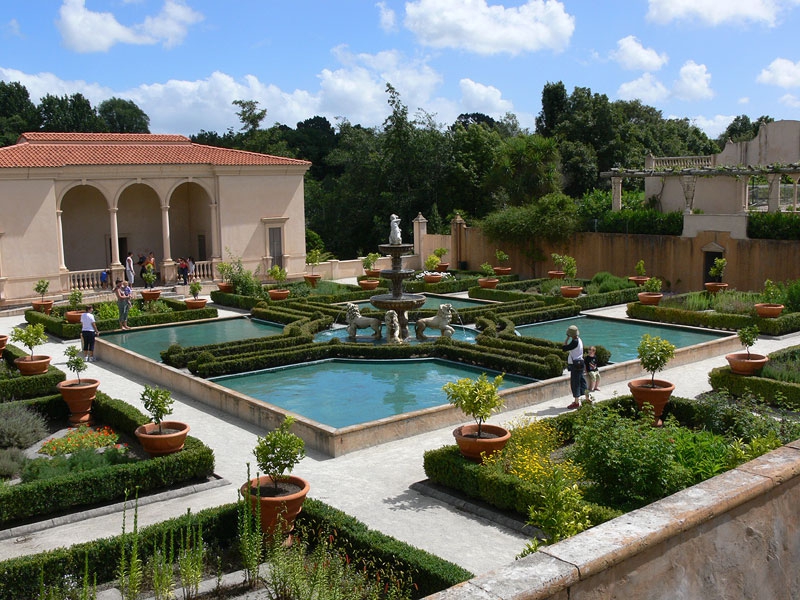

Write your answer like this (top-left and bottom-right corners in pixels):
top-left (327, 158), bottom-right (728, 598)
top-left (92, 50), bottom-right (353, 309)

top-left (212, 358), bottom-right (534, 428)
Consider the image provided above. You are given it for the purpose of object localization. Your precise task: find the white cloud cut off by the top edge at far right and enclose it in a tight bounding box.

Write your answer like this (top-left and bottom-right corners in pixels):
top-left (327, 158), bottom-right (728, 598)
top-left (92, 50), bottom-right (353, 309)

top-left (647, 0), bottom-right (798, 27)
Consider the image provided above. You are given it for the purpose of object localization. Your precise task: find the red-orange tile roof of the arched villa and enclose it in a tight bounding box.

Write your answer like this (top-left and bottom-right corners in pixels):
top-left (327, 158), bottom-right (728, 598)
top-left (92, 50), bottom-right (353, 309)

top-left (0, 132), bottom-right (311, 168)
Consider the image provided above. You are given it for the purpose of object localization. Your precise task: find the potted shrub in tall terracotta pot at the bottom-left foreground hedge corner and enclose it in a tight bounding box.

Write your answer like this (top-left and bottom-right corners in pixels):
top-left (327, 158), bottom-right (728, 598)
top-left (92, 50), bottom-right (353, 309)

top-left (239, 415), bottom-right (310, 535)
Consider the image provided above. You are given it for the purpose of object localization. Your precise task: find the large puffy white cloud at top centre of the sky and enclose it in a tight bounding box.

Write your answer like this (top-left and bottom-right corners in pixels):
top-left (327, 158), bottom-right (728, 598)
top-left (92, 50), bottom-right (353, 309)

top-left (405, 0), bottom-right (575, 56)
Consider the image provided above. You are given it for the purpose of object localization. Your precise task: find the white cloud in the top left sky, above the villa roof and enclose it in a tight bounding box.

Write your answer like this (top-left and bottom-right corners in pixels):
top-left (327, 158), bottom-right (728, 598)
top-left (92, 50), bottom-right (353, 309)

top-left (56, 0), bottom-right (203, 53)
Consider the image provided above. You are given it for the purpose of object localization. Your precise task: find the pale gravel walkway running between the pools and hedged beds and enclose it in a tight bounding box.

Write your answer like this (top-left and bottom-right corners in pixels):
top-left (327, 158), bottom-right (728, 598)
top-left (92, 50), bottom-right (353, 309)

top-left (0, 306), bottom-right (800, 574)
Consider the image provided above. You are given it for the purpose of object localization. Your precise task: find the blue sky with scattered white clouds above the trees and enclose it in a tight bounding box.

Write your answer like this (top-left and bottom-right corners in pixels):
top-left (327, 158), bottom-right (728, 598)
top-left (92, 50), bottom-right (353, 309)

top-left (0, 0), bottom-right (800, 137)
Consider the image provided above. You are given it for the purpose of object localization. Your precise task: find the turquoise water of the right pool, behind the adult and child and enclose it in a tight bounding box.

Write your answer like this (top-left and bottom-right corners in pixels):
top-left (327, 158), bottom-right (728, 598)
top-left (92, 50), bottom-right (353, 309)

top-left (516, 316), bottom-right (730, 363)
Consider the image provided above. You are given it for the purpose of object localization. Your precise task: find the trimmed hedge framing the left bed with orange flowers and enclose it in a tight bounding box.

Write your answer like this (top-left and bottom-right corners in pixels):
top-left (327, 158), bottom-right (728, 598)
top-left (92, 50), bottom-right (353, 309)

top-left (0, 392), bottom-right (214, 527)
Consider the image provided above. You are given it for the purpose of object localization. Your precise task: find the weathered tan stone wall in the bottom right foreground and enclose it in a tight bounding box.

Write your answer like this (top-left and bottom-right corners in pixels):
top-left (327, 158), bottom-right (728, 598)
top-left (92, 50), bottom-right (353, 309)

top-left (427, 440), bottom-right (800, 600)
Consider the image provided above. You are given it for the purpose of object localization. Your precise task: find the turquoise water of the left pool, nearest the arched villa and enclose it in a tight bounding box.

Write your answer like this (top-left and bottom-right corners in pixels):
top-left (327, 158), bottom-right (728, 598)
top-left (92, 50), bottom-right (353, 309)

top-left (100, 317), bottom-right (283, 362)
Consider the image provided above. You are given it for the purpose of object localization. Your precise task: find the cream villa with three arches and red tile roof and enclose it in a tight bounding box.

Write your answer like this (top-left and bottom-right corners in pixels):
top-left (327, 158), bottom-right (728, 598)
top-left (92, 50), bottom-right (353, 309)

top-left (0, 132), bottom-right (311, 305)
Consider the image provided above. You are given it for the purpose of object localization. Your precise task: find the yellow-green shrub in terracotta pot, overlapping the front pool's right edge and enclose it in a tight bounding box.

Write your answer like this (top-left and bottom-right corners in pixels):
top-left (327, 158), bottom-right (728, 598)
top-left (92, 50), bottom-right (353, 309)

top-left (442, 373), bottom-right (511, 462)
